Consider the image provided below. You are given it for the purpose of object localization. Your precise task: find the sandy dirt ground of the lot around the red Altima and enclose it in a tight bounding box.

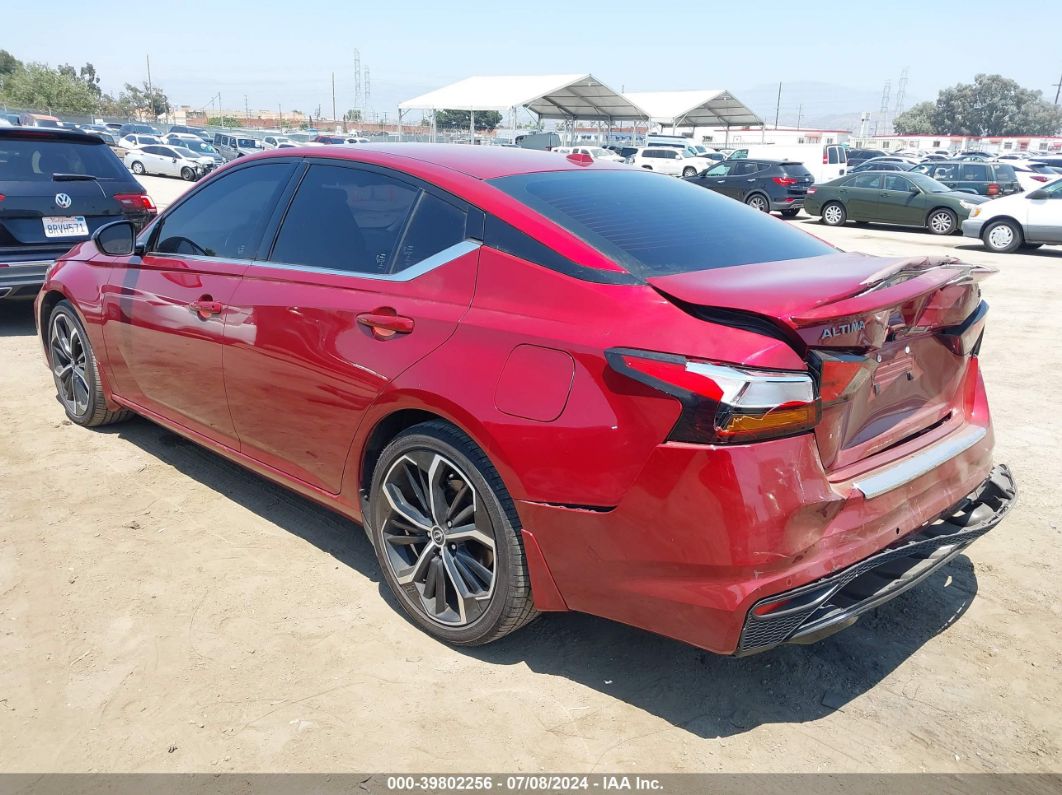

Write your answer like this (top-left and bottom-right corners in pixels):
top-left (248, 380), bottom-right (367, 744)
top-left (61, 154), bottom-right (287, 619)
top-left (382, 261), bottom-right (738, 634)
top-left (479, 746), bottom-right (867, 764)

top-left (0, 179), bottom-right (1062, 773)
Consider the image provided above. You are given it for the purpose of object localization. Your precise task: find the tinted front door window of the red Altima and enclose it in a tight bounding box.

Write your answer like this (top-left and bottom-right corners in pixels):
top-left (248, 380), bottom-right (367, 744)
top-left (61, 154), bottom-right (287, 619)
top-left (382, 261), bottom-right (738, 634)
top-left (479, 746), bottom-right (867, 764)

top-left (152, 163), bottom-right (292, 259)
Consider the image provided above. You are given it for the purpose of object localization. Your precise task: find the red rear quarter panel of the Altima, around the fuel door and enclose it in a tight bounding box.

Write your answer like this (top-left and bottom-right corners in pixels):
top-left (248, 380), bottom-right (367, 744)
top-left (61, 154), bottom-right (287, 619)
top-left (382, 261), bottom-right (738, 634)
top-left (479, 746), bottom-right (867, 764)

top-left (345, 246), bottom-right (804, 506)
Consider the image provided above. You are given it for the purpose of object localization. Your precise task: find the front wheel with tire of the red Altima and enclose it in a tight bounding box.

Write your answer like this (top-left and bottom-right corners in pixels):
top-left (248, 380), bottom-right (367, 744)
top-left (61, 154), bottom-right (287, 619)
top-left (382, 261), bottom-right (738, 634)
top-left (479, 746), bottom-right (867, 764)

top-left (48, 300), bottom-right (132, 428)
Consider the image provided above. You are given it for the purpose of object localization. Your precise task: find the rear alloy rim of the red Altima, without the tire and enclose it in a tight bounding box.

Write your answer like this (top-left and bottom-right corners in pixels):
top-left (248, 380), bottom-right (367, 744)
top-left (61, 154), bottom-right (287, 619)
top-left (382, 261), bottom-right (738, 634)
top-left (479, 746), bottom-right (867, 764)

top-left (380, 450), bottom-right (495, 626)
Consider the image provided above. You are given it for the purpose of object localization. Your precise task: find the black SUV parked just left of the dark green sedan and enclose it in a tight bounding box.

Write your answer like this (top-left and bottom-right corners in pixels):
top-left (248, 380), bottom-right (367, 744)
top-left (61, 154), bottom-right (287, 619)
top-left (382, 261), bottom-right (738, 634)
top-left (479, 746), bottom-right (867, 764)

top-left (684, 158), bottom-right (815, 218)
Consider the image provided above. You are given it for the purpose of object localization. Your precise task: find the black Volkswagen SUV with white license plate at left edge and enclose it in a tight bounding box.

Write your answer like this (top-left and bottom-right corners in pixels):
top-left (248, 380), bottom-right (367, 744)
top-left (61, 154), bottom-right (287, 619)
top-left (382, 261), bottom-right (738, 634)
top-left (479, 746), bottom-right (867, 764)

top-left (0, 127), bottom-right (156, 299)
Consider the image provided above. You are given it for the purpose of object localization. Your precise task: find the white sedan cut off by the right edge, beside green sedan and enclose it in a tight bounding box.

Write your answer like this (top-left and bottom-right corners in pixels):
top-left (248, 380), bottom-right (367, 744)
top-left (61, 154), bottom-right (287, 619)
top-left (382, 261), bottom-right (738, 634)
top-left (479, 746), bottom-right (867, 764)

top-left (962, 179), bottom-right (1062, 254)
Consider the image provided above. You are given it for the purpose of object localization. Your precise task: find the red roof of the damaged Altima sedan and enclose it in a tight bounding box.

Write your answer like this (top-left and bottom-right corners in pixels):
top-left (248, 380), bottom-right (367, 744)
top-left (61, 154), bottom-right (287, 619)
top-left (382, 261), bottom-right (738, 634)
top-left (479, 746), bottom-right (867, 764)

top-left (241, 143), bottom-right (627, 179)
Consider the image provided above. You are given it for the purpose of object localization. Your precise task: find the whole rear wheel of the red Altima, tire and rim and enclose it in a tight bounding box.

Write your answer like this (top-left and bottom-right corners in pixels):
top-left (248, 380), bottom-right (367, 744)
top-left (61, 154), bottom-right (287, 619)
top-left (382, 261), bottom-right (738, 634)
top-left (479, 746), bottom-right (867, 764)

top-left (369, 421), bottom-right (537, 645)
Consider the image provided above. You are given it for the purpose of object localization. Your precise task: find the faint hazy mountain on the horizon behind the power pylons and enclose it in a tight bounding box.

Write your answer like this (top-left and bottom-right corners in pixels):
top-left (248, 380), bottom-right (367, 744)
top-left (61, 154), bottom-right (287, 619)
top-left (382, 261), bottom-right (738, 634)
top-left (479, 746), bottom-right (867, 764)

top-left (734, 81), bottom-right (920, 132)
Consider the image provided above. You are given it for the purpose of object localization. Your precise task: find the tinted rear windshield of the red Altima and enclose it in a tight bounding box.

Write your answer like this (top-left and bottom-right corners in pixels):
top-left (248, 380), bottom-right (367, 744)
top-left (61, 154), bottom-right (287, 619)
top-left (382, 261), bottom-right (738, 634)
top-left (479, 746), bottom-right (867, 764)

top-left (490, 171), bottom-right (835, 279)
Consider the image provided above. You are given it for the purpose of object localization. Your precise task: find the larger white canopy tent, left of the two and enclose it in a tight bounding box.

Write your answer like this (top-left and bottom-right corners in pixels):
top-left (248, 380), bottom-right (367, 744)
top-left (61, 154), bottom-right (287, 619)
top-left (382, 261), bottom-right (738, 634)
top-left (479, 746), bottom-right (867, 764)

top-left (398, 74), bottom-right (649, 140)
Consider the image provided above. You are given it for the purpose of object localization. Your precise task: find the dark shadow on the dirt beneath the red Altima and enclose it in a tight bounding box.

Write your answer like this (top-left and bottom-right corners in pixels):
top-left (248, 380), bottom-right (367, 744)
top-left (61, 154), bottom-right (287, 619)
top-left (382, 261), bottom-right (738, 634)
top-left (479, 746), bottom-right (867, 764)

top-left (114, 419), bottom-right (977, 738)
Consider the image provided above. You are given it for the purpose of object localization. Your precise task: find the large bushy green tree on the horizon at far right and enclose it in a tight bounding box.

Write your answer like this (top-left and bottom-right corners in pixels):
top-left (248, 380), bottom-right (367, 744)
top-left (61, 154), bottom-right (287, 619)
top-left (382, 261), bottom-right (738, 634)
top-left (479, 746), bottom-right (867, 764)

top-left (895, 74), bottom-right (1062, 136)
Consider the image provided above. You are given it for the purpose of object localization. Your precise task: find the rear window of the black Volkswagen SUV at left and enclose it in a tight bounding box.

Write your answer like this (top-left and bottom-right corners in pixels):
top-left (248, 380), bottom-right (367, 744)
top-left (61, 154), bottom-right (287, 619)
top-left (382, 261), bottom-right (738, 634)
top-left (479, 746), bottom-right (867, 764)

top-left (0, 137), bottom-right (130, 182)
